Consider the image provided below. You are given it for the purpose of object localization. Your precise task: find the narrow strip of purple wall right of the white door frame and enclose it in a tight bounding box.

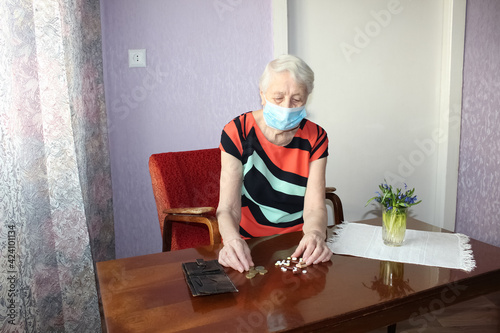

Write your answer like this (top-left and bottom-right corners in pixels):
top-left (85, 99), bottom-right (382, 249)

top-left (456, 0), bottom-right (500, 246)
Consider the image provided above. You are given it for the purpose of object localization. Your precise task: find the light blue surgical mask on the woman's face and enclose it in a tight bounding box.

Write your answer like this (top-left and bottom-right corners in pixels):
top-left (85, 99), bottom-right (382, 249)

top-left (264, 99), bottom-right (307, 131)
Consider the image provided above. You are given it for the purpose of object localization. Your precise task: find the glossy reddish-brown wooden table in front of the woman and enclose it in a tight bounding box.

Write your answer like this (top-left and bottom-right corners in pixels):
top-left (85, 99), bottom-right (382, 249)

top-left (97, 219), bottom-right (500, 333)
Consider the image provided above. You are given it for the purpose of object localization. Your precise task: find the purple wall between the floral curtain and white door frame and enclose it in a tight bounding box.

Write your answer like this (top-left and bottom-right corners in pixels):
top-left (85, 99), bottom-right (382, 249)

top-left (101, 0), bottom-right (273, 258)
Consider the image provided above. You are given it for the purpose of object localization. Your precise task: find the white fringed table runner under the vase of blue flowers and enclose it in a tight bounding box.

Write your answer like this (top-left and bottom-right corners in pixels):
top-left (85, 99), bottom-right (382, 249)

top-left (327, 222), bottom-right (476, 272)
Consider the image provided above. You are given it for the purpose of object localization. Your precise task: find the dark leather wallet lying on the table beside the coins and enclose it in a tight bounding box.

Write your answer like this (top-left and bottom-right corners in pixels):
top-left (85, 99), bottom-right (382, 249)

top-left (182, 259), bottom-right (238, 296)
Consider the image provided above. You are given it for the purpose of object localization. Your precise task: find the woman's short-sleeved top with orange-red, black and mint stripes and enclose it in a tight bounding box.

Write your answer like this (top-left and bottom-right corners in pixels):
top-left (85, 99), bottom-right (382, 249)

top-left (219, 112), bottom-right (328, 238)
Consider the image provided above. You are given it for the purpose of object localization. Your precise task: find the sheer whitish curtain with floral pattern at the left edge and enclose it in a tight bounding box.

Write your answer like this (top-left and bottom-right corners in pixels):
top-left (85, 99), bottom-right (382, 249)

top-left (0, 0), bottom-right (114, 332)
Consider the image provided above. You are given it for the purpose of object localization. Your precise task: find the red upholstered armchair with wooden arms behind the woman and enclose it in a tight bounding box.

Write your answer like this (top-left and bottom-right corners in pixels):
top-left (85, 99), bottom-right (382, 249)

top-left (149, 148), bottom-right (344, 251)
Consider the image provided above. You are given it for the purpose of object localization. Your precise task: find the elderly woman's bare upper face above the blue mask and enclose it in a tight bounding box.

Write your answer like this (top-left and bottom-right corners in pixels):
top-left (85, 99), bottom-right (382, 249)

top-left (260, 71), bottom-right (307, 108)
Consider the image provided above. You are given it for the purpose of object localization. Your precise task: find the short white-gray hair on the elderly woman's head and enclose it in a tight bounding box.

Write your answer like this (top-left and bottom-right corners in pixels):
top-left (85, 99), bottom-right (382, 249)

top-left (259, 54), bottom-right (314, 95)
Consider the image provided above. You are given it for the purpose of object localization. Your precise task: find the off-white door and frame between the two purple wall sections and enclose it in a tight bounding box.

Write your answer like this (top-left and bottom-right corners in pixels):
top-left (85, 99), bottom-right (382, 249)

top-left (287, 0), bottom-right (465, 229)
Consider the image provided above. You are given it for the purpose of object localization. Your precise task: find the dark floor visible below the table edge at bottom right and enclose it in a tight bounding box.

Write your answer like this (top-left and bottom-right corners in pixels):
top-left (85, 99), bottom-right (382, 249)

top-left (369, 290), bottom-right (500, 333)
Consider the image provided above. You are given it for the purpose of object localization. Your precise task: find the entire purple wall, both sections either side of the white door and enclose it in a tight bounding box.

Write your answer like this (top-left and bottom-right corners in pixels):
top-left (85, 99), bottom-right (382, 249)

top-left (101, 0), bottom-right (500, 258)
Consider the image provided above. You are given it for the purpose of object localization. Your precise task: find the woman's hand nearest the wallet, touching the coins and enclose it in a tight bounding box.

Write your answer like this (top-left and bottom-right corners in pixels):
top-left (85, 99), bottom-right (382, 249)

top-left (219, 238), bottom-right (254, 273)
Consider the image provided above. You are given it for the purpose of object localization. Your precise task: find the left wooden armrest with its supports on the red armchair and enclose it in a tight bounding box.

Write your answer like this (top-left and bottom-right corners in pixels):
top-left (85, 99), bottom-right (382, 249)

top-left (163, 211), bottom-right (222, 251)
